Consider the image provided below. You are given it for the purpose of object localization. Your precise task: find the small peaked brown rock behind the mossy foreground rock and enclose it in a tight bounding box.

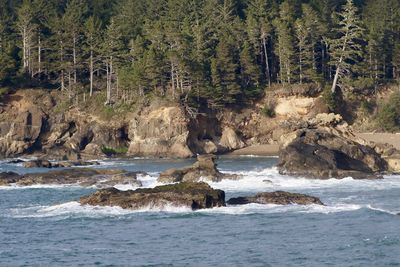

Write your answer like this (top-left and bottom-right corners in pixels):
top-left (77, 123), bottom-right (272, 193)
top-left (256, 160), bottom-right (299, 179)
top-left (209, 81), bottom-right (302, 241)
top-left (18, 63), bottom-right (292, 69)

top-left (157, 155), bottom-right (241, 183)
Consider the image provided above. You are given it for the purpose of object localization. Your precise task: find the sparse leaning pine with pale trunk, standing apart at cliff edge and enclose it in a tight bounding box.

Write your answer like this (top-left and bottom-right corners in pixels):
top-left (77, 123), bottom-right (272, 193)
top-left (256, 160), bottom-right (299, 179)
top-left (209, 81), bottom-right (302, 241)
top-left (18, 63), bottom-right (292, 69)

top-left (330, 0), bottom-right (363, 93)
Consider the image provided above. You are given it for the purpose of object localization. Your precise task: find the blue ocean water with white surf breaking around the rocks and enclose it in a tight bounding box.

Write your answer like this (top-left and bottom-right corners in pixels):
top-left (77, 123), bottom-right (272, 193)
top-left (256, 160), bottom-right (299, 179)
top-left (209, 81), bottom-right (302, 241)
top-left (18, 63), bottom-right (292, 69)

top-left (0, 157), bottom-right (400, 266)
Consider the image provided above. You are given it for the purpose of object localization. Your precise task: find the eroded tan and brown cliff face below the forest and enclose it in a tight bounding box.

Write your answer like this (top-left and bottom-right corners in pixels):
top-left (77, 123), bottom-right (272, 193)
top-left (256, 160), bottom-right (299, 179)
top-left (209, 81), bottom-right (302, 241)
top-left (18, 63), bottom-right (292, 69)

top-left (0, 90), bottom-right (324, 159)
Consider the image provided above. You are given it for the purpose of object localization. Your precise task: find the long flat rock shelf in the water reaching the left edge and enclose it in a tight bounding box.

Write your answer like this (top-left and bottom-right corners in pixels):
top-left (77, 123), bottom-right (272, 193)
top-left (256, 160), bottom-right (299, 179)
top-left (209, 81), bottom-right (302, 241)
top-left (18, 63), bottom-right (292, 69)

top-left (0, 168), bottom-right (142, 188)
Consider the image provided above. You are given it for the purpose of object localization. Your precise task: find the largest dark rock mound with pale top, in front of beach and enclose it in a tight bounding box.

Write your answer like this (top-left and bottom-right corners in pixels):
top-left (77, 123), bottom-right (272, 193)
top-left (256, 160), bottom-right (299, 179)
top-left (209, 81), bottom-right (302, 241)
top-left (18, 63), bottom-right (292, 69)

top-left (278, 115), bottom-right (388, 179)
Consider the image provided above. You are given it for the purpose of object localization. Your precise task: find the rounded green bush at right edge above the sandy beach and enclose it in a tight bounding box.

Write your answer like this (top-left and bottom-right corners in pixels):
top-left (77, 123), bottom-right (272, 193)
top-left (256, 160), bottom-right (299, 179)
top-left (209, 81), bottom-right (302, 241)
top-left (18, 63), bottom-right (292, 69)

top-left (376, 93), bottom-right (400, 131)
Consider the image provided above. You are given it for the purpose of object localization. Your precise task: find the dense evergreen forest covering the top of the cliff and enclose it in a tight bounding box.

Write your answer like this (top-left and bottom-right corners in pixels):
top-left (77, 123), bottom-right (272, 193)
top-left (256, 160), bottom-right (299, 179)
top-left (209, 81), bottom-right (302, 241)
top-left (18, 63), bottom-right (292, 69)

top-left (0, 0), bottom-right (400, 107)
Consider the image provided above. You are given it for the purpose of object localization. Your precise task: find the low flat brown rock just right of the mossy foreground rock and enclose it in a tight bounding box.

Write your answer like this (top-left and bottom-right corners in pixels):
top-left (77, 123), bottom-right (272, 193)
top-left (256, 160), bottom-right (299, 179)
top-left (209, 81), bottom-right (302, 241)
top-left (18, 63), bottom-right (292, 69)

top-left (227, 191), bottom-right (324, 205)
